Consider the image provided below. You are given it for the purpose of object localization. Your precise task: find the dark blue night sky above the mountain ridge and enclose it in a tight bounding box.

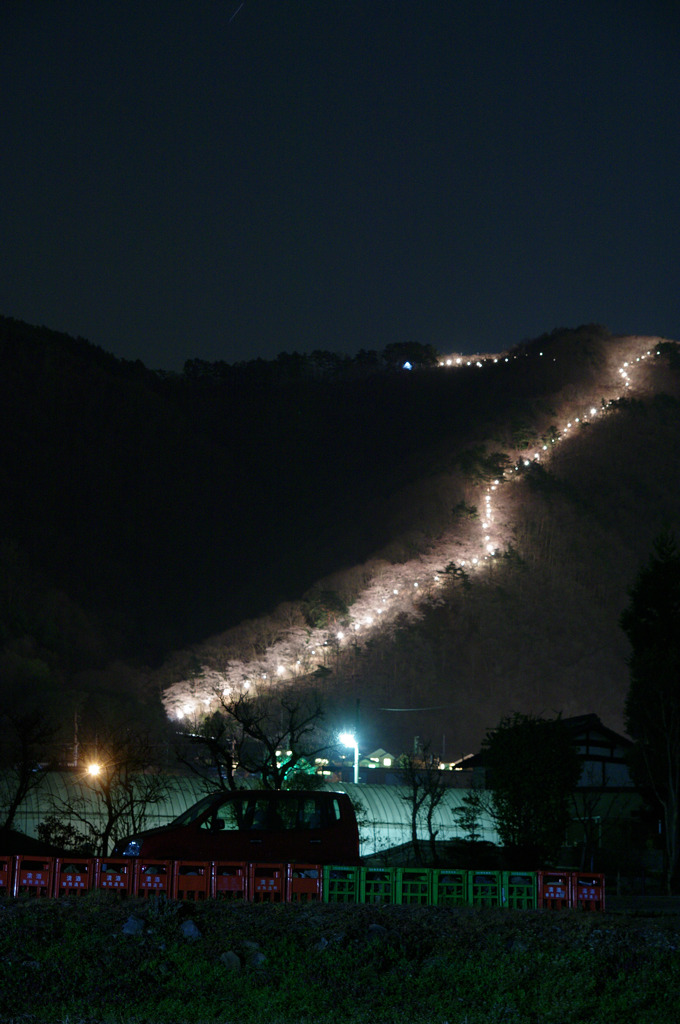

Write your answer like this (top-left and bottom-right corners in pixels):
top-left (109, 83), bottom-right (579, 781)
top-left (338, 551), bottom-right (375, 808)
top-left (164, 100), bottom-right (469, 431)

top-left (0, 0), bottom-right (680, 370)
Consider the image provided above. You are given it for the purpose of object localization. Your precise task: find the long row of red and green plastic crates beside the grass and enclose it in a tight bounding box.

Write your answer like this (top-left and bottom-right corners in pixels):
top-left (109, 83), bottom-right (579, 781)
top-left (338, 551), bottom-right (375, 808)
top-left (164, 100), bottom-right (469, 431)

top-left (0, 855), bottom-right (604, 910)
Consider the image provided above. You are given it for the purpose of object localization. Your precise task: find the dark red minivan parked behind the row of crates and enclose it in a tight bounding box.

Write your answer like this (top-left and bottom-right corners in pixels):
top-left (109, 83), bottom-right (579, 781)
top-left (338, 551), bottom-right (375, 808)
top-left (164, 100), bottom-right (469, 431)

top-left (114, 790), bottom-right (359, 864)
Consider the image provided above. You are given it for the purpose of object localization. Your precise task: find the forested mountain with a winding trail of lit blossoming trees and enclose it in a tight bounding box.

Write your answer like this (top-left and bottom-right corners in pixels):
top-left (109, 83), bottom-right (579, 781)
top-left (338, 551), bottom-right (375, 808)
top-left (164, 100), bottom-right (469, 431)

top-left (0, 319), bottom-right (680, 758)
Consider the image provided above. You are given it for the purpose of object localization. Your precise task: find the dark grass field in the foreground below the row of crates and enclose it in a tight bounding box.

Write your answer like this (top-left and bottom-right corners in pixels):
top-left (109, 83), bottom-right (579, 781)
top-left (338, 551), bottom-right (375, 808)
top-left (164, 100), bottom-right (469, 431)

top-left (0, 894), bottom-right (680, 1024)
